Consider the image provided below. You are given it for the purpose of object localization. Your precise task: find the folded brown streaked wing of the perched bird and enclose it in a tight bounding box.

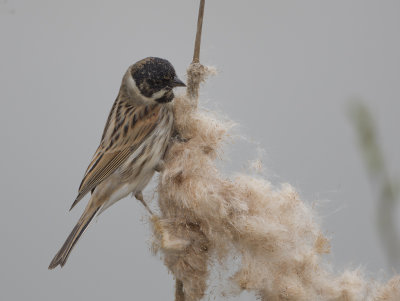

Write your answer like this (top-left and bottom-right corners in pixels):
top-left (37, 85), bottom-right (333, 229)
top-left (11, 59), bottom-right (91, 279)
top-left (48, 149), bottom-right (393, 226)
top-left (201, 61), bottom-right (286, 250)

top-left (70, 105), bottom-right (161, 210)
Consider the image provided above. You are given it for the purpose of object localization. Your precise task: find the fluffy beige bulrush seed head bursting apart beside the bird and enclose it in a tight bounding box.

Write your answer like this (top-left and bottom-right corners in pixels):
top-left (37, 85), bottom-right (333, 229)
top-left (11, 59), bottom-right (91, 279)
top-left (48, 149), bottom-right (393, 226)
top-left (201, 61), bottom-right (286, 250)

top-left (152, 63), bottom-right (400, 301)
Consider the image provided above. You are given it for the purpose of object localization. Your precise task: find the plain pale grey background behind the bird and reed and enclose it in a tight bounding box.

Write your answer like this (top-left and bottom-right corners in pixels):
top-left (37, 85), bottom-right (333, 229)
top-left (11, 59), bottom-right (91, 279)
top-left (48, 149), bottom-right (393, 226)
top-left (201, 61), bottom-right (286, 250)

top-left (0, 0), bottom-right (400, 301)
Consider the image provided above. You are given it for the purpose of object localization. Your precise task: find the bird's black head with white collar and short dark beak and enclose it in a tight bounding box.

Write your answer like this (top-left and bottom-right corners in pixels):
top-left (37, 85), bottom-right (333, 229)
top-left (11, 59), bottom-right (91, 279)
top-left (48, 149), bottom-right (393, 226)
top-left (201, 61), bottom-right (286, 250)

top-left (123, 57), bottom-right (186, 103)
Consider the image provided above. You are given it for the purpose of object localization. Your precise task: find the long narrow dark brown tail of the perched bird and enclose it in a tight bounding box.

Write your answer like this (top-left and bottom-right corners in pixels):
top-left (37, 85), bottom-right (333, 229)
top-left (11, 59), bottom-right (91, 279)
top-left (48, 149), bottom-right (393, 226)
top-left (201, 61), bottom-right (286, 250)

top-left (49, 206), bottom-right (100, 270)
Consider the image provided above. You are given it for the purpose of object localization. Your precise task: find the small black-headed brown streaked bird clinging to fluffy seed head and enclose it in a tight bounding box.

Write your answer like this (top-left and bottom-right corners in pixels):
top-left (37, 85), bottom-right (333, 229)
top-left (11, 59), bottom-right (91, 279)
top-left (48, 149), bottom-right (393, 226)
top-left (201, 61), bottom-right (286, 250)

top-left (49, 57), bottom-right (186, 269)
